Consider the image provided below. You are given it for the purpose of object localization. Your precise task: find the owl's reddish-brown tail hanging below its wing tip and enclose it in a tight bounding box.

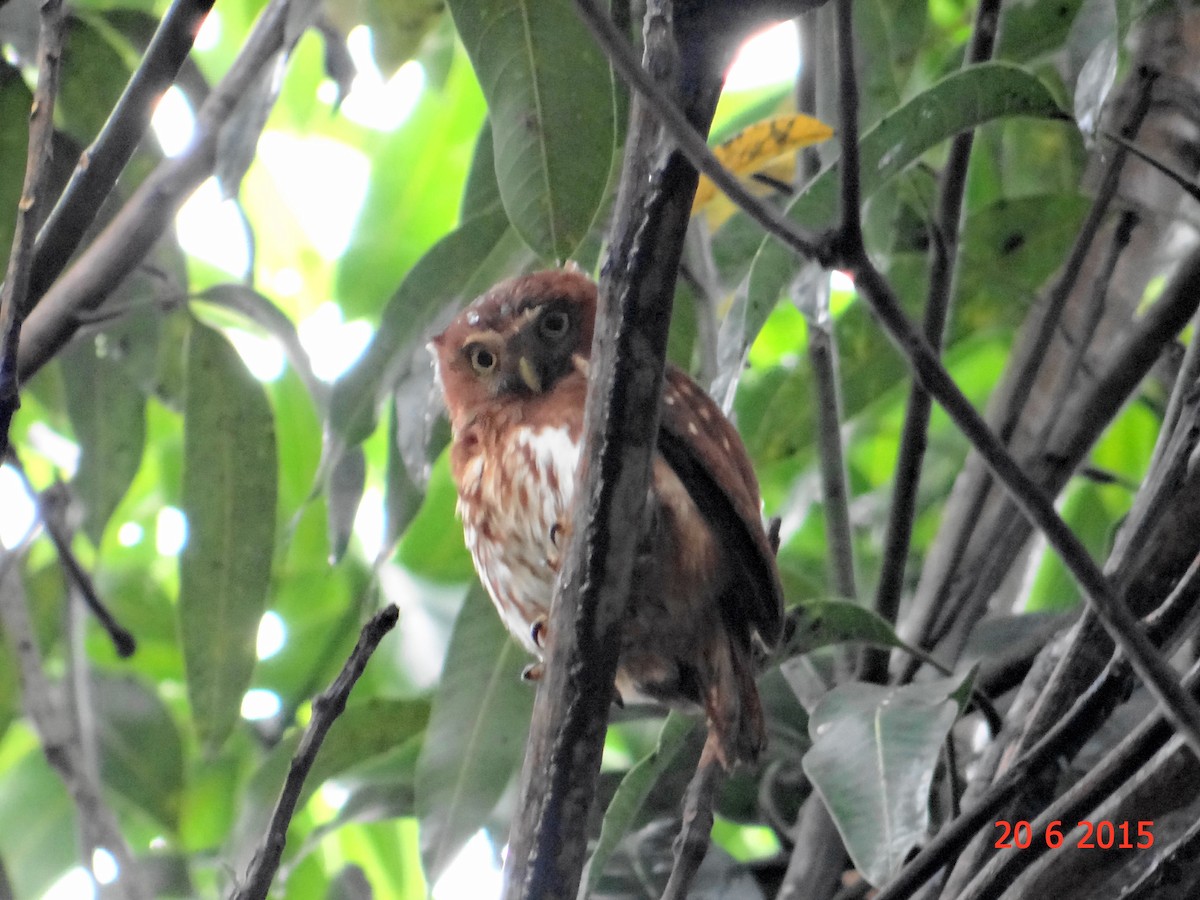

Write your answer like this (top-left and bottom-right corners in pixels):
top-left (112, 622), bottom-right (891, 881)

top-left (704, 641), bottom-right (767, 770)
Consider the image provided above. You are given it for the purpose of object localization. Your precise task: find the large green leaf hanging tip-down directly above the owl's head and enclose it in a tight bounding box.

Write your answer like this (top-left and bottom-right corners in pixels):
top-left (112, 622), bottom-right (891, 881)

top-left (450, 0), bottom-right (616, 260)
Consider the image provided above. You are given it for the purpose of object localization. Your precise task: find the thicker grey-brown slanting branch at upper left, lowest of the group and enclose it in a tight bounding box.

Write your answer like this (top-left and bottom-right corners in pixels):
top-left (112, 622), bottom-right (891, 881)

top-left (19, 0), bottom-right (319, 379)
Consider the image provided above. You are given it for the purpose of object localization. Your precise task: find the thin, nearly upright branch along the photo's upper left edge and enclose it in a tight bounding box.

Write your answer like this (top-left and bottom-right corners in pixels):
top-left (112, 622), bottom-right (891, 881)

top-left (0, 0), bottom-right (64, 457)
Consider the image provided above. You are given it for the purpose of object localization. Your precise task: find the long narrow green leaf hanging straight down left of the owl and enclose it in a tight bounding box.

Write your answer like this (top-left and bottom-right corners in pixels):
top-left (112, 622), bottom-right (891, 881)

top-left (179, 323), bottom-right (278, 750)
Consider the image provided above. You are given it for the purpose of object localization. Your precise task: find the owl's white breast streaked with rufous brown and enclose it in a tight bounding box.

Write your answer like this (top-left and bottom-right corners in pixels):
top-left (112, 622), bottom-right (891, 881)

top-left (455, 425), bottom-right (580, 655)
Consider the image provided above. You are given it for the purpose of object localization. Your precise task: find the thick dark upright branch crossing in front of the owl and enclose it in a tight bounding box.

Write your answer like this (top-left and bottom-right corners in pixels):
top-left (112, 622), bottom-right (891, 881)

top-left (504, 0), bottom-right (715, 900)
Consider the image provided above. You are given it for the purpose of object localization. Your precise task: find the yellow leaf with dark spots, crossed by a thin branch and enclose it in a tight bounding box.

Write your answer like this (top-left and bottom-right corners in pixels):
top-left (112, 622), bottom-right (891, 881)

top-left (691, 113), bottom-right (833, 229)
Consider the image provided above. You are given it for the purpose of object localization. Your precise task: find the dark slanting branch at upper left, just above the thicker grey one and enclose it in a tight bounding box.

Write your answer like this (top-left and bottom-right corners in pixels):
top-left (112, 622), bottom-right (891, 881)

top-left (26, 0), bottom-right (214, 311)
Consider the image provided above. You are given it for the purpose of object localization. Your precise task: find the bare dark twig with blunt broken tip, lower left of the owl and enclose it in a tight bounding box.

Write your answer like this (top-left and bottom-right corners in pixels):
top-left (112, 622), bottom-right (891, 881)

top-left (230, 604), bottom-right (400, 900)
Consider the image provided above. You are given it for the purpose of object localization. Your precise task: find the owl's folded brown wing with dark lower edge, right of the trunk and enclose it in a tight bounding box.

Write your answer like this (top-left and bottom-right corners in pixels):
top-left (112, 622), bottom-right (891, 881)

top-left (659, 366), bottom-right (784, 647)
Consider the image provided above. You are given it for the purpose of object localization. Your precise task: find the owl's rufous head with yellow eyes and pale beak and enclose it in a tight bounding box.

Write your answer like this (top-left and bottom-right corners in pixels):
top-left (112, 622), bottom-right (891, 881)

top-left (430, 269), bottom-right (596, 418)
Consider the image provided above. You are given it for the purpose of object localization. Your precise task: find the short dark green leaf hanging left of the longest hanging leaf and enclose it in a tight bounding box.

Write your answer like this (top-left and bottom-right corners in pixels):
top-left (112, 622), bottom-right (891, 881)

top-left (61, 340), bottom-right (145, 547)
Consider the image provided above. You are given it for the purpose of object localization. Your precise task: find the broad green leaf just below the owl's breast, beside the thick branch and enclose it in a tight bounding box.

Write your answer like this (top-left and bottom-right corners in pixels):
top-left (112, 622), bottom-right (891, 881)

top-left (416, 588), bottom-right (534, 883)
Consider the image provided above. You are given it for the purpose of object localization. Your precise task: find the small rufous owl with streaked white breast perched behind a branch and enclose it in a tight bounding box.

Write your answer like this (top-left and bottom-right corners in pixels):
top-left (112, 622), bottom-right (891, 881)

top-left (431, 271), bottom-right (784, 768)
